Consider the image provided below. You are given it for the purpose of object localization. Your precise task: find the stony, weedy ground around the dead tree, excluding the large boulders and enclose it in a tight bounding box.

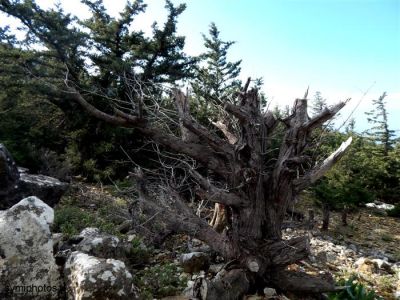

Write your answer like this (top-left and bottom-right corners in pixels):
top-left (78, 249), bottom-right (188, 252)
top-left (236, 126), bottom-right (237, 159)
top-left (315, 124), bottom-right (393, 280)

top-left (56, 186), bottom-right (400, 299)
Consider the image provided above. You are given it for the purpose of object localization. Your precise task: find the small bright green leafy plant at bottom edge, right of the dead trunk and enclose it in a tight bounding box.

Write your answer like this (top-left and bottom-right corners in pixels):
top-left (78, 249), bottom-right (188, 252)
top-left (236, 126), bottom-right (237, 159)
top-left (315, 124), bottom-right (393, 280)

top-left (328, 276), bottom-right (382, 300)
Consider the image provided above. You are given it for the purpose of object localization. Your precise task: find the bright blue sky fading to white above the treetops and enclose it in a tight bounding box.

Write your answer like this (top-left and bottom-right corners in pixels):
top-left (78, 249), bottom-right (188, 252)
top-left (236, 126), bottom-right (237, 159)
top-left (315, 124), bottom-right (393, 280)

top-left (1, 0), bottom-right (400, 134)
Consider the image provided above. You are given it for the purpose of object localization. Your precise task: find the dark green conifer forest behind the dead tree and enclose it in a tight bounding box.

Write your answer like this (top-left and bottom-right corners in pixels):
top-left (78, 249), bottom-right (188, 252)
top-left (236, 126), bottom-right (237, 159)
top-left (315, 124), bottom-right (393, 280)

top-left (0, 1), bottom-right (400, 218)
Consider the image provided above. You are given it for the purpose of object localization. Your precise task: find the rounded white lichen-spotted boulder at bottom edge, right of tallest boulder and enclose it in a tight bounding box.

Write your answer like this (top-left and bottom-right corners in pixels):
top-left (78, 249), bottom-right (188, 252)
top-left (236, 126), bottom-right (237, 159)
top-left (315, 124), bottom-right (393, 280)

top-left (65, 251), bottom-right (137, 300)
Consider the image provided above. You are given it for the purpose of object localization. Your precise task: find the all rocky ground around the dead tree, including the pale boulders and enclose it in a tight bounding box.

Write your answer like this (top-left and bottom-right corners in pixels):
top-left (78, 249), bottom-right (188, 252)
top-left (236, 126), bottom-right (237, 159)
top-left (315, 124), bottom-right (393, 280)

top-left (0, 144), bottom-right (400, 300)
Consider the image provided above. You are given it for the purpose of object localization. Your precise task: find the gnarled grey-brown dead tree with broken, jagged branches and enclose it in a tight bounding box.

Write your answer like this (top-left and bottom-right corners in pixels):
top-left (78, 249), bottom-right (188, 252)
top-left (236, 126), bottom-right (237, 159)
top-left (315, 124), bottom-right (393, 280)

top-left (67, 80), bottom-right (351, 299)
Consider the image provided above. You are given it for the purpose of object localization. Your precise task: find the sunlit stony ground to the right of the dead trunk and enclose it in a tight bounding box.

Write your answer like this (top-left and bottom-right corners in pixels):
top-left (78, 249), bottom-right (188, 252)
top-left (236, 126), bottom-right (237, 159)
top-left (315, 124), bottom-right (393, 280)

top-left (286, 193), bottom-right (400, 299)
